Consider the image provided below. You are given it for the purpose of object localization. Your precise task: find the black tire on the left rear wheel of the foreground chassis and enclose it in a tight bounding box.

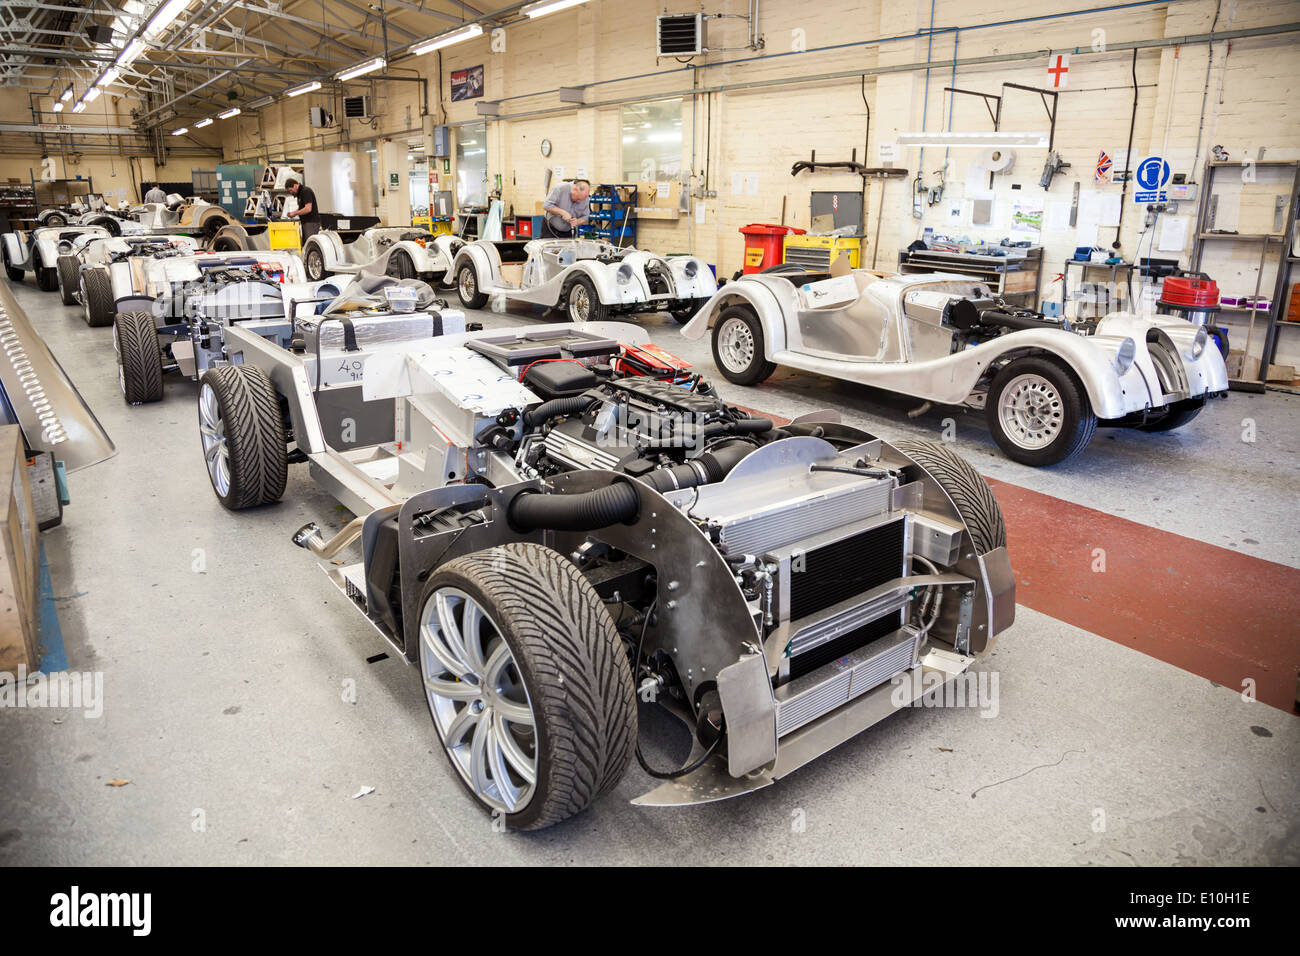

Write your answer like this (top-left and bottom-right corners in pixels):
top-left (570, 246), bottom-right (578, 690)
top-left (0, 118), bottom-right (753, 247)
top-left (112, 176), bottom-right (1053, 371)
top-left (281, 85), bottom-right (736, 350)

top-left (199, 365), bottom-right (289, 511)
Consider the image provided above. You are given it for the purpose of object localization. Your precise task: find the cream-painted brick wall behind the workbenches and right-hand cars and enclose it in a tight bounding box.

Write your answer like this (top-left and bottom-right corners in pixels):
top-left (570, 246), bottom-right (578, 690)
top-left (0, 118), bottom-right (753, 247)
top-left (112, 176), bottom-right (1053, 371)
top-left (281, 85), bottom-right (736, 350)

top-left (218, 0), bottom-right (1300, 353)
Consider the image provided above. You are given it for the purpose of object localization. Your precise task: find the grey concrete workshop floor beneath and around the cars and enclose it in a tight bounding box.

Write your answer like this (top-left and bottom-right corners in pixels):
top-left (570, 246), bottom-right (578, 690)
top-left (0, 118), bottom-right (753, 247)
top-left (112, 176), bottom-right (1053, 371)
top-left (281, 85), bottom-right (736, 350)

top-left (0, 277), bottom-right (1300, 865)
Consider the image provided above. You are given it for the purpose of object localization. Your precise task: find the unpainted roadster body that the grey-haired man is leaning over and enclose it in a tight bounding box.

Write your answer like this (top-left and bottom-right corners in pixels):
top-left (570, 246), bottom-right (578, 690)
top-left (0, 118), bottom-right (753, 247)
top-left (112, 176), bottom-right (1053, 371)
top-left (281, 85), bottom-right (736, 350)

top-left (452, 239), bottom-right (718, 312)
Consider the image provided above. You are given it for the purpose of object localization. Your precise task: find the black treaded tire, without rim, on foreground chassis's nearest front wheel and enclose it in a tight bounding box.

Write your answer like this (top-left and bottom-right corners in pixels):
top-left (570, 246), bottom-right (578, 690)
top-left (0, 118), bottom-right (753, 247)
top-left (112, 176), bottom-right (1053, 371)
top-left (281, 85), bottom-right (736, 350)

top-left (420, 542), bottom-right (637, 830)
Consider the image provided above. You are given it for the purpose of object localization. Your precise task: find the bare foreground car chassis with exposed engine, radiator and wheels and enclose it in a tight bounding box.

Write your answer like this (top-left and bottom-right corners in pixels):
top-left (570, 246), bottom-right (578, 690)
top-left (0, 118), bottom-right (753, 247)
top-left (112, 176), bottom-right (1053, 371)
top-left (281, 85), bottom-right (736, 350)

top-left (198, 316), bottom-right (1015, 829)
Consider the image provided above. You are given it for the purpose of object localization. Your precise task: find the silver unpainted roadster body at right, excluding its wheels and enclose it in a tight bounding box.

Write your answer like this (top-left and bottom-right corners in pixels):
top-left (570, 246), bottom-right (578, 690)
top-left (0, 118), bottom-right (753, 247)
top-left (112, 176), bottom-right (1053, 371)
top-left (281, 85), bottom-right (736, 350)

top-left (683, 271), bottom-right (1227, 420)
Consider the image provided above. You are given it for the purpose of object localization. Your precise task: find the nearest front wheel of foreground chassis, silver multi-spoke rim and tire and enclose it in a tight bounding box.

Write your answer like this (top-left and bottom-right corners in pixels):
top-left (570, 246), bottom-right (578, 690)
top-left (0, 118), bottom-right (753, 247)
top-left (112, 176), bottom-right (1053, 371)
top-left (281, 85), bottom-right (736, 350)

top-left (420, 542), bottom-right (637, 830)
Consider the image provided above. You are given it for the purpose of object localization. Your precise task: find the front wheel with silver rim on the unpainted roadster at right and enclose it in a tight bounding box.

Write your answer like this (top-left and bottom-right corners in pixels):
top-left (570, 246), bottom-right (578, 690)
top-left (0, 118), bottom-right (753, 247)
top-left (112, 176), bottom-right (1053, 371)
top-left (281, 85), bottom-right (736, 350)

top-left (984, 355), bottom-right (1097, 468)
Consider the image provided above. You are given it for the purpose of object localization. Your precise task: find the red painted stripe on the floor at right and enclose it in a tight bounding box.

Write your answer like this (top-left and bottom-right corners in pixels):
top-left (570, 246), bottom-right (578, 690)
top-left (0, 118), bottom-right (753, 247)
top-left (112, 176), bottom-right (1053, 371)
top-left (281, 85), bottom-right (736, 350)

top-left (988, 479), bottom-right (1300, 711)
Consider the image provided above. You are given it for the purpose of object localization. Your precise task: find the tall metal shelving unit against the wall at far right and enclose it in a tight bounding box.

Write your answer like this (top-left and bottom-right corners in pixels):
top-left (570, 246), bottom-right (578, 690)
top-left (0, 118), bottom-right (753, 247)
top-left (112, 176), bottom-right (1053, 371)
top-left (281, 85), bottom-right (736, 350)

top-left (1191, 160), bottom-right (1300, 390)
